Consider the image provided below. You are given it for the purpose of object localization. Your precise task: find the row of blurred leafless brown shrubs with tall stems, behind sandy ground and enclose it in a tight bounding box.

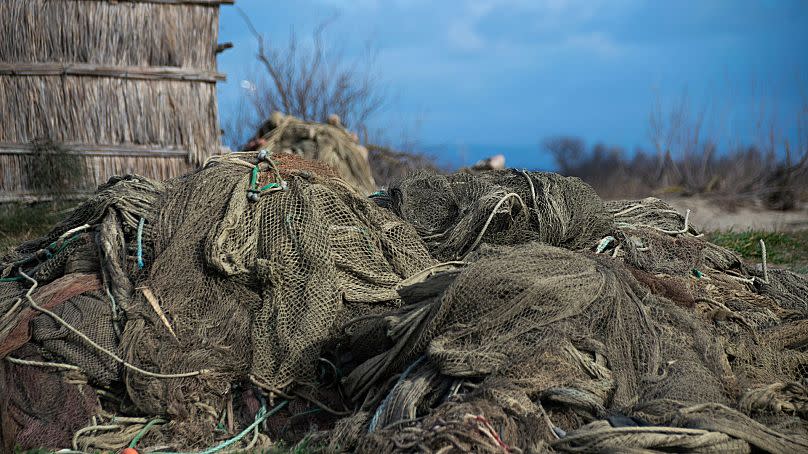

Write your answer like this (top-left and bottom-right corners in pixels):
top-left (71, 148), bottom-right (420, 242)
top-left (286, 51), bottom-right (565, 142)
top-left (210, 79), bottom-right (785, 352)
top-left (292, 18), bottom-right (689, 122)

top-left (544, 87), bottom-right (808, 210)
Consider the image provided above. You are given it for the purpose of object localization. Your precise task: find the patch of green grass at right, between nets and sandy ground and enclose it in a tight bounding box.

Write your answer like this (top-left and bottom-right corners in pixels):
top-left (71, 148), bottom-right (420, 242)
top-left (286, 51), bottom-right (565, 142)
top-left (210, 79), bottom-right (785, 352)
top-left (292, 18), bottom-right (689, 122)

top-left (707, 230), bottom-right (808, 273)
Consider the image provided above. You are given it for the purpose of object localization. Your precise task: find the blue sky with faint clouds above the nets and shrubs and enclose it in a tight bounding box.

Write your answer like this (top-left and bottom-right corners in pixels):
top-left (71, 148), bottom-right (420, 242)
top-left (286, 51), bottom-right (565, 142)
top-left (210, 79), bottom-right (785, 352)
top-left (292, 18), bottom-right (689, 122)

top-left (219, 0), bottom-right (808, 168)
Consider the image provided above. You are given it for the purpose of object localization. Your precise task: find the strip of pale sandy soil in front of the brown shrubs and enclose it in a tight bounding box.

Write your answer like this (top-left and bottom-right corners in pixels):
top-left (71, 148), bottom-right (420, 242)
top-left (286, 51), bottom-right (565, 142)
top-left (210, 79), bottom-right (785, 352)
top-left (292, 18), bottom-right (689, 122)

top-left (662, 196), bottom-right (808, 232)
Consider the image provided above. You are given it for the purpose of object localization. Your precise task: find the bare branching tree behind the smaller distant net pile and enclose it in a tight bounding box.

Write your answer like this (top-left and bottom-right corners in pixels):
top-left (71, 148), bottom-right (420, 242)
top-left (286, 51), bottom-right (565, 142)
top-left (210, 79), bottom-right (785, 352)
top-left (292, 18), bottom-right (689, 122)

top-left (230, 10), bottom-right (386, 148)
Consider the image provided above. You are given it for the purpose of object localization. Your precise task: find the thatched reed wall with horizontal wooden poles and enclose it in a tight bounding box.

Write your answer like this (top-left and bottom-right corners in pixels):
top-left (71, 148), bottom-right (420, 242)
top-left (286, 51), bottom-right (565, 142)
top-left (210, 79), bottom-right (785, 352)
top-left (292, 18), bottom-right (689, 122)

top-left (0, 0), bottom-right (232, 201)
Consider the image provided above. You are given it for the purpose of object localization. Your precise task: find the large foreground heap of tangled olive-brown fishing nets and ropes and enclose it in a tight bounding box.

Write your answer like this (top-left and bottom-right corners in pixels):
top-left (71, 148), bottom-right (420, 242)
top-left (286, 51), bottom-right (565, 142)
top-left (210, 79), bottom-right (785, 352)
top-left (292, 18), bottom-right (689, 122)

top-left (0, 150), bottom-right (808, 453)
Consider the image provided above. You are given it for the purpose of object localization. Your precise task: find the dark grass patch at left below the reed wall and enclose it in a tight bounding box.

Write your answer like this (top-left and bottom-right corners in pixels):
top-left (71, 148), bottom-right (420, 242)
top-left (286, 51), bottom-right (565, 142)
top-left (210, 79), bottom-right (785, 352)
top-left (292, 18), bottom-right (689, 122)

top-left (0, 201), bottom-right (76, 255)
